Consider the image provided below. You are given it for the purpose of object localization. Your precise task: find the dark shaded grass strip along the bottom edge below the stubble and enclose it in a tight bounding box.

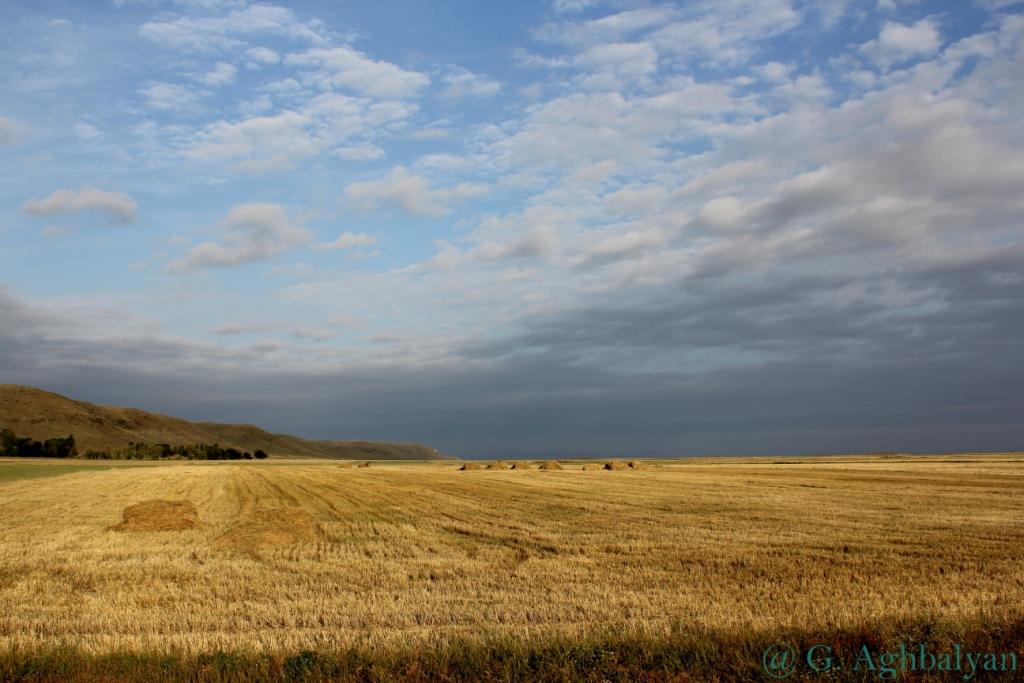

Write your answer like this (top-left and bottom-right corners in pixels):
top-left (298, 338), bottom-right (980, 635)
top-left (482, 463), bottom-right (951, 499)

top-left (0, 617), bottom-right (1024, 683)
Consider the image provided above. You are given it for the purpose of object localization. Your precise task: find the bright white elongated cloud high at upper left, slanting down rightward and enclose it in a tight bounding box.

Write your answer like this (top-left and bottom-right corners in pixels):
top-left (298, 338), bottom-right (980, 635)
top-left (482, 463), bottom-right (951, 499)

top-left (285, 46), bottom-right (430, 99)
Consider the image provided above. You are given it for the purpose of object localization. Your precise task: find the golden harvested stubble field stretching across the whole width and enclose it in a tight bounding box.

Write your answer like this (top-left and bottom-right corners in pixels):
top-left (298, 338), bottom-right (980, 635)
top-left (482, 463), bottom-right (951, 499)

top-left (0, 455), bottom-right (1024, 653)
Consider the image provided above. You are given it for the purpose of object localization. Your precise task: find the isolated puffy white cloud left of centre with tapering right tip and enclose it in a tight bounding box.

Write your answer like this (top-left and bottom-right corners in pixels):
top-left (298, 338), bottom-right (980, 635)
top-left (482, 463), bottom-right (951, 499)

top-left (345, 166), bottom-right (487, 218)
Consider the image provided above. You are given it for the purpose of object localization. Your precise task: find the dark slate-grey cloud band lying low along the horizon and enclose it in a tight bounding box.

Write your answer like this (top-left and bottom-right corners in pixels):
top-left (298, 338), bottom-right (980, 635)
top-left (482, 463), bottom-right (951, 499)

top-left (0, 264), bottom-right (1024, 456)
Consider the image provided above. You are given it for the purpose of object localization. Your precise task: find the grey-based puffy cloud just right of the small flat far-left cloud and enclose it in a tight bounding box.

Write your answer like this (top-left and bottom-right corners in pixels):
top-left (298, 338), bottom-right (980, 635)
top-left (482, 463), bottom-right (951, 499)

top-left (167, 204), bottom-right (313, 272)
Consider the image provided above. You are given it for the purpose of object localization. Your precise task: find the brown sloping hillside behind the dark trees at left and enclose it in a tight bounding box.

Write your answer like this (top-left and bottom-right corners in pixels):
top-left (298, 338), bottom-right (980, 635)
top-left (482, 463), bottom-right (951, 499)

top-left (0, 384), bottom-right (445, 460)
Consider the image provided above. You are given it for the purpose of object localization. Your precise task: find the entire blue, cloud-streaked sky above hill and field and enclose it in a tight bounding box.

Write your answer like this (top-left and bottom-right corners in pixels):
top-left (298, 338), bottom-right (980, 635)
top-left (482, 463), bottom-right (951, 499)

top-left (0, 0), bottom-right (1024, 457)
